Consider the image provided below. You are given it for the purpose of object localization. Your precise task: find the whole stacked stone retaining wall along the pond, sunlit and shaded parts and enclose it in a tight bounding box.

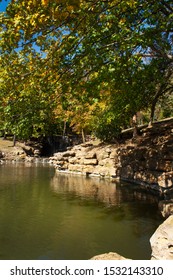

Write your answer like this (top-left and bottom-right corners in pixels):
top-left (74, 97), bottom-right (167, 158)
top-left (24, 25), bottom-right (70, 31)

top-left (50, 120), bottom-right (173, 194)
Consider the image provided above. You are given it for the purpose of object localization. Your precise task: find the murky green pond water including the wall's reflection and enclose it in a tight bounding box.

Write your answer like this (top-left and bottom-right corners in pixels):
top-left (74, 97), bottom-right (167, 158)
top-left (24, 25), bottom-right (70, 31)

top-left (0, 164), bottom-right (162, 260)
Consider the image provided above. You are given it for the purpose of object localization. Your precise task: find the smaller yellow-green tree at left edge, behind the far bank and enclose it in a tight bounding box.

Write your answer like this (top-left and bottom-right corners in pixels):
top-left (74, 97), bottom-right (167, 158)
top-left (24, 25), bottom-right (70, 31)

top-left (0, 48), bottom-right (62, 139)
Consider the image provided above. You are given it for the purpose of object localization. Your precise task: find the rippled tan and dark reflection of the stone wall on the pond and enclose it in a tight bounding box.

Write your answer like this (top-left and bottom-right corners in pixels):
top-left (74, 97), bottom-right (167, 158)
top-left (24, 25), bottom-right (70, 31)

top-left (51, 174), bottom-right (160, 216)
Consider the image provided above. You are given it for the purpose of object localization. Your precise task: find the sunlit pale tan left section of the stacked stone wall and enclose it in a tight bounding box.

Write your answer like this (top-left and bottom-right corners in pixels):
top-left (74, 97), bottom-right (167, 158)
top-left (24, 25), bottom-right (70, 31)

top-left (50, 143), bottom-right (118, 177)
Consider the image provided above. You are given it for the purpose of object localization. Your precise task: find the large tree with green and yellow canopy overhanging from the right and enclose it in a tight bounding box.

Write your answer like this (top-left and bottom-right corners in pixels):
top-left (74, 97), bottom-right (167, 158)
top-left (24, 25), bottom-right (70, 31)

top-left (0, 0), bottom-right (173, 138)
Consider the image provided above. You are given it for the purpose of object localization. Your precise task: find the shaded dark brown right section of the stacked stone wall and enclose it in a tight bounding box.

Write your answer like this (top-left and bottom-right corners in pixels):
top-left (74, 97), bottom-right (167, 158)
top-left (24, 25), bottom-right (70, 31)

top-left (120, 121), bottom-right (173, 196)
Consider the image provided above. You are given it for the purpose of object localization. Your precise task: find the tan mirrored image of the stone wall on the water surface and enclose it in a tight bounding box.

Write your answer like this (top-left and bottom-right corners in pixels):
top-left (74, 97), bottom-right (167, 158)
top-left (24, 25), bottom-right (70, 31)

top-left (51, 173), bottom-right (158, 206)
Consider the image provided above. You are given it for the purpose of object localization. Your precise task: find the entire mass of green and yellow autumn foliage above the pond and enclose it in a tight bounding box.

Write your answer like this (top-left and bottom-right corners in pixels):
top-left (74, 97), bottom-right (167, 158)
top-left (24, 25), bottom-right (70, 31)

top-left (0, 0), bottom-right (173, 140)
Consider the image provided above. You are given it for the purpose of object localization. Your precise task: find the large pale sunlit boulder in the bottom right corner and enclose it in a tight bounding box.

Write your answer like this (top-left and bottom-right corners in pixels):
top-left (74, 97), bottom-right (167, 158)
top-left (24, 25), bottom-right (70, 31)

top-left (150, 215), bottom-right (173, 260)
